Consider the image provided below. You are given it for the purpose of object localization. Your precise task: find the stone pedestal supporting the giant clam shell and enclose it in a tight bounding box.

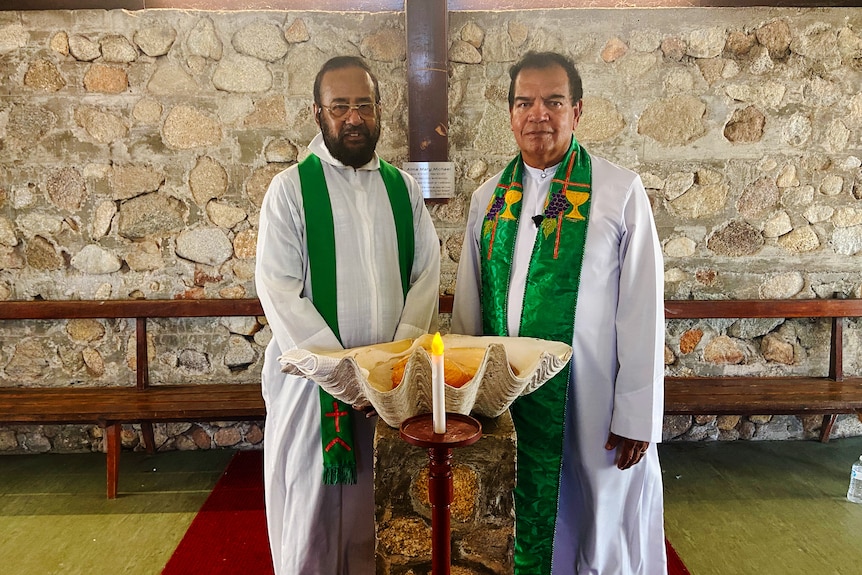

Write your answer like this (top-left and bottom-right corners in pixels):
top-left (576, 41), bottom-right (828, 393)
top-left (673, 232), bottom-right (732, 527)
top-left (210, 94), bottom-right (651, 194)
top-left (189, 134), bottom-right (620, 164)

top-left (374, 412), bottom-right (515, 575)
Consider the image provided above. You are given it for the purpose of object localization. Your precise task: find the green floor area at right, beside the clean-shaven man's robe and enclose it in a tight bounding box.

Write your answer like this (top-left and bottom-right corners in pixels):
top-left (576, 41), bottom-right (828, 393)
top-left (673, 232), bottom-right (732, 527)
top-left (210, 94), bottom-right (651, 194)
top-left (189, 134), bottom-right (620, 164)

top-left (660, 438), bottom-right (862, 575)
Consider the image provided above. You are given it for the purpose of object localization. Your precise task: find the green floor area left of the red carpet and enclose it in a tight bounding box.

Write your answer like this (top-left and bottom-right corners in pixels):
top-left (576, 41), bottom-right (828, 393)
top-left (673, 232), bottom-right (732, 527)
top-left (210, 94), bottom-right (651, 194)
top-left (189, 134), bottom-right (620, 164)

top-left (0, 450), bottom-right (233, 575)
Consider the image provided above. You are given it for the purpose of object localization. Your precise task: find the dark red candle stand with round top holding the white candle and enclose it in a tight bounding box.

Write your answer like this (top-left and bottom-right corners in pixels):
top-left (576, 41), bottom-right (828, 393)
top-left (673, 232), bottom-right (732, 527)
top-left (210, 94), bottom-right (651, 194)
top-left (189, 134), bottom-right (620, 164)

top-left (401, 413), bottom-right (482, 575)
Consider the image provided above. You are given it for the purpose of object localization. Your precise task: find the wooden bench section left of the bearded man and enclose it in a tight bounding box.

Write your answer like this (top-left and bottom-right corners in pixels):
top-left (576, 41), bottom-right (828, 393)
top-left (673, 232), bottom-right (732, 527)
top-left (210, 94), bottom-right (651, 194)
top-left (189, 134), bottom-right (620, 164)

top-left (0, 299), bottom-right (266, 499)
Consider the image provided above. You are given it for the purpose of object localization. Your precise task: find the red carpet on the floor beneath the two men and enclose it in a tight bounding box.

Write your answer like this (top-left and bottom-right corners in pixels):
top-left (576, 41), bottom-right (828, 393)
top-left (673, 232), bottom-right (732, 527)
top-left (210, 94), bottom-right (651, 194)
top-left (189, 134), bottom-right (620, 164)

top-left (162, 451), bottom-right (691, 575)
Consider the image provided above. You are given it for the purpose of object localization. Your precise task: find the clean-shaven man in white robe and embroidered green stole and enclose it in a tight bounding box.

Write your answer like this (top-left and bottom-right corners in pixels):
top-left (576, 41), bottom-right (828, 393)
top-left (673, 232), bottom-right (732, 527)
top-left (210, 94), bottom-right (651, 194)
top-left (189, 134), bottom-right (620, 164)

top-left (452, 52), bottom-right (667, 575)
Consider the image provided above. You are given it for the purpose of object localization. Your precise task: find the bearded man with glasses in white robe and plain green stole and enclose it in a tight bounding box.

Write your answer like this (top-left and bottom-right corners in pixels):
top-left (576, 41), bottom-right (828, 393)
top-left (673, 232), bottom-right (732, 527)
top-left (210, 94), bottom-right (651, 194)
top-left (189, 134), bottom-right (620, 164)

top-left (255, 56), bottom-right (440, 575)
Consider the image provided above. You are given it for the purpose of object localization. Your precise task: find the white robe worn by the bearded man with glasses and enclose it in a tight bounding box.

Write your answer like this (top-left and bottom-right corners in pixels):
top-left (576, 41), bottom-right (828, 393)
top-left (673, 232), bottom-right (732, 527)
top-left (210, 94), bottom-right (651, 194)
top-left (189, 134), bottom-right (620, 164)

top-left (251, 134), bottom-right (440, 575)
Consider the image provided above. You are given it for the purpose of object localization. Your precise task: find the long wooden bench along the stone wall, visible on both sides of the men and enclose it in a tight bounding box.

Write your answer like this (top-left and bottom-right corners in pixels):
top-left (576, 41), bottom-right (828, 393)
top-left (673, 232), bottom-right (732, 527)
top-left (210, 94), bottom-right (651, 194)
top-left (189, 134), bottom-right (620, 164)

top-left (0, 296), bottom-right (862, 498)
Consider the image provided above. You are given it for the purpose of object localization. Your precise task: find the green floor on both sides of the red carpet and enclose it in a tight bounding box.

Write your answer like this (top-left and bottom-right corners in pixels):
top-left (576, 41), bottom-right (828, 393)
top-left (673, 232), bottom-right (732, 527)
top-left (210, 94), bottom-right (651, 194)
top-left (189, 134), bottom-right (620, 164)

top-left (0, 438), bottom-right (862, 575)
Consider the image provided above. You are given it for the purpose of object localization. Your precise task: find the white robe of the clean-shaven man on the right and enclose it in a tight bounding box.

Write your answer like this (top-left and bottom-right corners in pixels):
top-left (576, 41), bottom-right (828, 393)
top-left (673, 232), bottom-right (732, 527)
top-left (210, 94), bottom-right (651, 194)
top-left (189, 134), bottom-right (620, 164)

top-left (452, 152), bottom-right (667, 575)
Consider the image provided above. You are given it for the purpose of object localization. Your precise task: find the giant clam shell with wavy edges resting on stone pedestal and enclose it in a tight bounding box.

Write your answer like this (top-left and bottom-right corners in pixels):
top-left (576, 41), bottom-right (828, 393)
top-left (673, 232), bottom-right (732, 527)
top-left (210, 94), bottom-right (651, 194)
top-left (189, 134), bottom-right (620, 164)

top-left (279, 335), bottom-right (572, 427)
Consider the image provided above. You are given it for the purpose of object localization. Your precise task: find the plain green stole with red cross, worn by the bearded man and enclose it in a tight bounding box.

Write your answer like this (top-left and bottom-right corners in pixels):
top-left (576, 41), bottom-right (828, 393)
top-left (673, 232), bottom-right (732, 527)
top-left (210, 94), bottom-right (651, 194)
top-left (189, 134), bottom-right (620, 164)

top-left (299, 154), bottom-right (414, 485)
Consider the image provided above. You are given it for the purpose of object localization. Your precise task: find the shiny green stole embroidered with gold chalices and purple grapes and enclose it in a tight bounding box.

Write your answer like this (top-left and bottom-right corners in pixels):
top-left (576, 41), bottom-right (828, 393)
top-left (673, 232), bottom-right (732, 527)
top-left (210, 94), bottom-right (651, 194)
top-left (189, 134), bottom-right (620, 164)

top-left (480, 138), bottom-right (592, 575)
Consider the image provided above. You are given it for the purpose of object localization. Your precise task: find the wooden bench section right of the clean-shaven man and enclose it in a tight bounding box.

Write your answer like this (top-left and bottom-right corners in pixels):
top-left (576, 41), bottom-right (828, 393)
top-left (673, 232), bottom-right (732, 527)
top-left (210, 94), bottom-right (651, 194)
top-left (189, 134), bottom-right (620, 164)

top-left (664, 299), bottom-right (862, 442)
